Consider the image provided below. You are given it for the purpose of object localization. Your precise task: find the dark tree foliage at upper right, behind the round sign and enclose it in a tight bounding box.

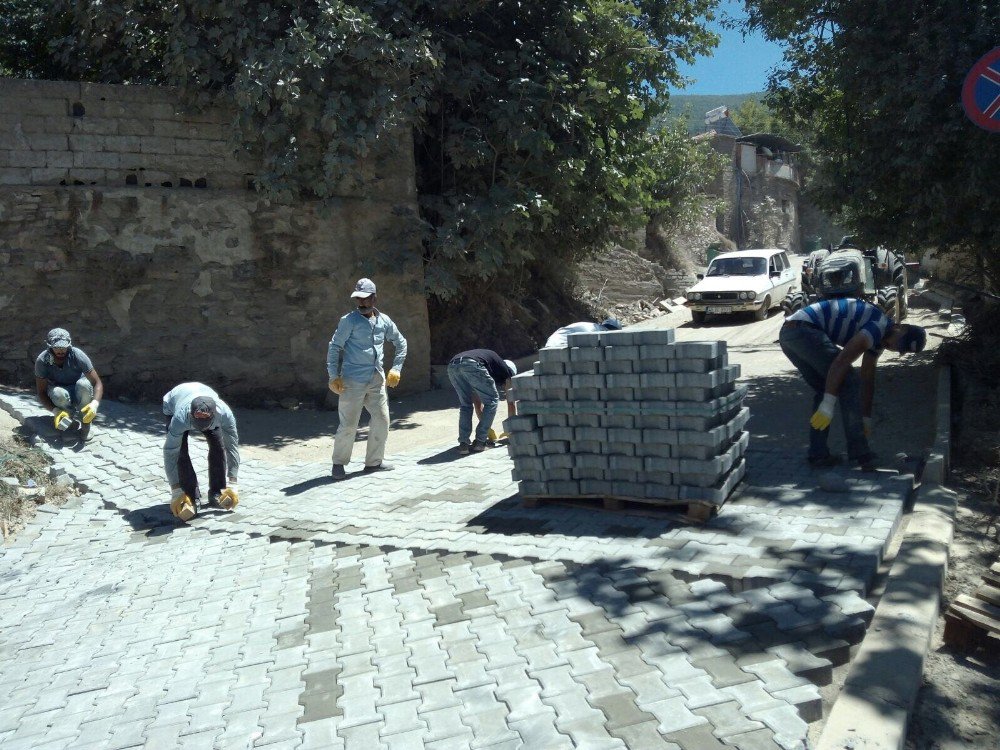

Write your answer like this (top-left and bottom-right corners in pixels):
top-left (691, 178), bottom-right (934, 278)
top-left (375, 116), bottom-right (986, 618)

top-left (747, 0), bottom-right (1000, 285)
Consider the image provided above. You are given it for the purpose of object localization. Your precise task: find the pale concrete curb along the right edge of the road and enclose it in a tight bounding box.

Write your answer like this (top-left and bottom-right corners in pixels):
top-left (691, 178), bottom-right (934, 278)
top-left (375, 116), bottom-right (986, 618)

top-left (817, 368), bottom-right (956, 750)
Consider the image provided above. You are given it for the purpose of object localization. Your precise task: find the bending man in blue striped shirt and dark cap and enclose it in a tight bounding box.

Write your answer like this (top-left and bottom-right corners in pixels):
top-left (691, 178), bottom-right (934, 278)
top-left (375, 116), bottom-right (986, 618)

top-left (778, 299), bottom-right (927, 471)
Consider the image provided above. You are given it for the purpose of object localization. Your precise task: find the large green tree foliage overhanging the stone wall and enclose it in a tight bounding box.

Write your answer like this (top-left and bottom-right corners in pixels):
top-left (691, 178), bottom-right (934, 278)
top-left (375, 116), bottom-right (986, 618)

top-left (0, 0), bottom-right (717, 298)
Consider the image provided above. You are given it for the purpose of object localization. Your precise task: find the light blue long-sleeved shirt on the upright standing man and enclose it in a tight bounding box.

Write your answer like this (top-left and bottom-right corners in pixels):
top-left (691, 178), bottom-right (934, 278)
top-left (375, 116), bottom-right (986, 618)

top-left (326, 310), bottom-right (406, 383)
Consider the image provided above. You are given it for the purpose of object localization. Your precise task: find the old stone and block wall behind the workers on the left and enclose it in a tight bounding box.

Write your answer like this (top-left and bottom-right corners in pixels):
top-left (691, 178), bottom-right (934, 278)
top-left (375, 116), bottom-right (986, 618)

top-left (0, 80), bottom-right (430, 402)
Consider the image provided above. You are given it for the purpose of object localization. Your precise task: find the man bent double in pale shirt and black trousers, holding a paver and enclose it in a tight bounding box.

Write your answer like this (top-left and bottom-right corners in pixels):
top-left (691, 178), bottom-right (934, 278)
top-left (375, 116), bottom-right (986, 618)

top-left (163, 383), bottom-right (240, 521)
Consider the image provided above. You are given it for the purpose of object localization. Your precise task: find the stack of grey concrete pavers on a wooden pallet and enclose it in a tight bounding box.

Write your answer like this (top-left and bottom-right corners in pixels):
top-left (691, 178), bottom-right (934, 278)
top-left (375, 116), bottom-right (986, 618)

top-left (504, 330), bottom-right (750, 506)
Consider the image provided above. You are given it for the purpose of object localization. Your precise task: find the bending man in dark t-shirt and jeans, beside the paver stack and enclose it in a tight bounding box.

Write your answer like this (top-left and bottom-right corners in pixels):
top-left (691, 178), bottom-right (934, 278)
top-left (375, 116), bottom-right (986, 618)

top-left (448, 349), bottom-right (517, 455)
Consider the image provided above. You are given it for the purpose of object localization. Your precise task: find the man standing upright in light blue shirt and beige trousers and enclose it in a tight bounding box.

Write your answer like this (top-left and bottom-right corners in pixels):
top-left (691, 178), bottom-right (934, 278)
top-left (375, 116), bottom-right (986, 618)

top-left (326, 279), bottom-right (406, 481)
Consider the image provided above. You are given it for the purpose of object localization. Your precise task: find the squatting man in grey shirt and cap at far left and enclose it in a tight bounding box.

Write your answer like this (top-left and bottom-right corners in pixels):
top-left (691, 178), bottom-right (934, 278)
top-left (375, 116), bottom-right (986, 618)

top-left (35, 328), bottom-right (104, 441)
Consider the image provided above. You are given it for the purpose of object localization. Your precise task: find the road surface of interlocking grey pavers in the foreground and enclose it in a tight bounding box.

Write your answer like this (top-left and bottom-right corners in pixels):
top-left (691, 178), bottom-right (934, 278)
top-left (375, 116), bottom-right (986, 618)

top-left (0, 391), bottom-right (909, 750)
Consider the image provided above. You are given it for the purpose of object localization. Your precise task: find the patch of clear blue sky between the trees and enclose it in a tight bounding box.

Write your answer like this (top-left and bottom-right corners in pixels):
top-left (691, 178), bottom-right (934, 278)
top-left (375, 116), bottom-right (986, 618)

top-left (672, 0), bottom-right (781, 94)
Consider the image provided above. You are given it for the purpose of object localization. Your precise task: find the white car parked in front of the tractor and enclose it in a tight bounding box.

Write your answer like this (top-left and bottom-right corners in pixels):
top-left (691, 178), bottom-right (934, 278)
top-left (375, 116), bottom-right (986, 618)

top-left (685, 248), bottom-right (796, 323)
